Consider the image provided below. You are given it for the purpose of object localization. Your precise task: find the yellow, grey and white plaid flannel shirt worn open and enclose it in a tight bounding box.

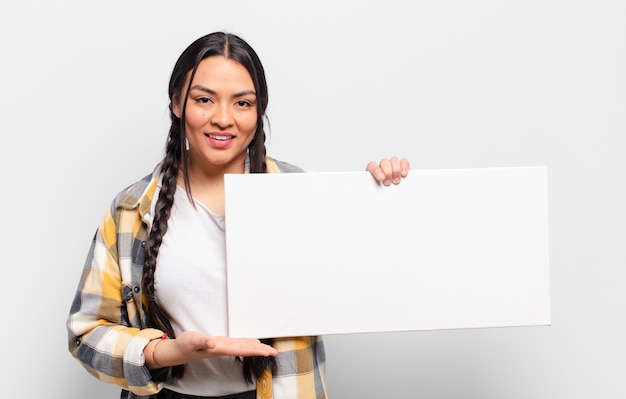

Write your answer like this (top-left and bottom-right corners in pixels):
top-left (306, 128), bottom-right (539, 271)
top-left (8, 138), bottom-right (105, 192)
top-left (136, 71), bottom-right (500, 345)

top-left (67, 157), bottom-right (328, 399)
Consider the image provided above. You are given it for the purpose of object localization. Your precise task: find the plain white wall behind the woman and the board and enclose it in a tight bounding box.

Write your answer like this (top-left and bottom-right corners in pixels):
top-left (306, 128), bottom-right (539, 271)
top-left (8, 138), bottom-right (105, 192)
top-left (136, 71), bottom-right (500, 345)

top-left (0, 0), bottom-right (626, 399)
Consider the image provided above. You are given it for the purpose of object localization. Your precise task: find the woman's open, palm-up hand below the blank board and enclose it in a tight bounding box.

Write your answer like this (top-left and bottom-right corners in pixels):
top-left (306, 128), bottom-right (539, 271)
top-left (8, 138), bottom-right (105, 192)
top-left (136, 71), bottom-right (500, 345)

top-left (144, 331), bottom-right (278, 370)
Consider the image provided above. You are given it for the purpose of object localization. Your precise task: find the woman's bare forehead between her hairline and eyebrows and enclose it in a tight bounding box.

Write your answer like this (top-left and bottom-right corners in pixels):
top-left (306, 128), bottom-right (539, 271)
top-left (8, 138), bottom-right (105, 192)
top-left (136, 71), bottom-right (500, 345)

top-left (192, 55), bottom-right (254, 90)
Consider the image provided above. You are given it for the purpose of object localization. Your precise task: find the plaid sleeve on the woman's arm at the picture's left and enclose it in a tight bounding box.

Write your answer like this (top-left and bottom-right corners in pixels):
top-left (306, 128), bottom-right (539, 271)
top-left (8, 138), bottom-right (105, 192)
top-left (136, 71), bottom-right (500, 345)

top-left (66, 206), bottom-right (163, 395)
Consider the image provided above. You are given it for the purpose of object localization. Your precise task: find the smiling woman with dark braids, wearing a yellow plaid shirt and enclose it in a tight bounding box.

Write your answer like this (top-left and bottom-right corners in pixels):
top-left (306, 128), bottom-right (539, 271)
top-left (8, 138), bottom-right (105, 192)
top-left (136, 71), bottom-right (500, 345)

top-left (67, 32), bottom-right (409, 399)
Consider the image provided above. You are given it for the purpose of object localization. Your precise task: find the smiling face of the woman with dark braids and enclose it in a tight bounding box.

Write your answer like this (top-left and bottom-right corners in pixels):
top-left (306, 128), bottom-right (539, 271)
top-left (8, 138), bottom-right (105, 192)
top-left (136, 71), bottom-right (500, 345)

top-left (173, 56), bottom-right (257, 173)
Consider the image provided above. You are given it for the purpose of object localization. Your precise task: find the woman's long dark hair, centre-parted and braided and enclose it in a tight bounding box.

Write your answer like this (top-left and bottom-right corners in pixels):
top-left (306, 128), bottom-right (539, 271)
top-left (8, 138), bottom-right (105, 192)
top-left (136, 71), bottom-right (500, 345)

top-left (143, 32), bottom-right (276, 382)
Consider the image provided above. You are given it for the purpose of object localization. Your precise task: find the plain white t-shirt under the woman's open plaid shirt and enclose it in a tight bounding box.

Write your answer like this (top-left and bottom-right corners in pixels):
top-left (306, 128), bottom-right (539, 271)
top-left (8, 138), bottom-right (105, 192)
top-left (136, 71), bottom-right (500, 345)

top-left (155, 186), bottom-right (255, 396)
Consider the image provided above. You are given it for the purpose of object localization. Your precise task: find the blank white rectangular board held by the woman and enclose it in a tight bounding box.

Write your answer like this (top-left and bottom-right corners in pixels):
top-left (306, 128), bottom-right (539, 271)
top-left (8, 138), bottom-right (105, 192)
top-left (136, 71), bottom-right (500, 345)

top-left (225, 166), bottom-right (550, 338)
